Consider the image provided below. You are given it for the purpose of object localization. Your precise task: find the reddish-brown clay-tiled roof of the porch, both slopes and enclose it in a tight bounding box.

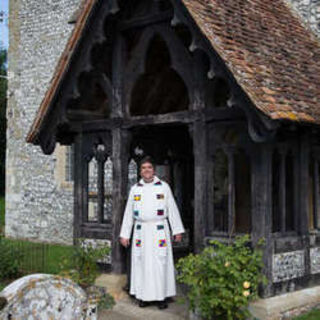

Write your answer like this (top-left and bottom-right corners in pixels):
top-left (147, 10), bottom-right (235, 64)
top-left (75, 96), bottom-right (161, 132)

top-left (26, 0), bottom-right (320, 142)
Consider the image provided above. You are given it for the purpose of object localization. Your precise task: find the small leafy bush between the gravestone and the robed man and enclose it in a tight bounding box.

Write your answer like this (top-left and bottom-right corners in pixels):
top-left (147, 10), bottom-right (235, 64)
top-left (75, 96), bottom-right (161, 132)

top-left (59, 238), bottom-right (111, 288)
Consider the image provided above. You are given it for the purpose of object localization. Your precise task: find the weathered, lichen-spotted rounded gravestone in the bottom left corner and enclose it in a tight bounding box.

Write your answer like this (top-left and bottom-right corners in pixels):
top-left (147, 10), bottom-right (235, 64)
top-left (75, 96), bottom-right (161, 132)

top-left (0, 273), bottom-right (98, 320)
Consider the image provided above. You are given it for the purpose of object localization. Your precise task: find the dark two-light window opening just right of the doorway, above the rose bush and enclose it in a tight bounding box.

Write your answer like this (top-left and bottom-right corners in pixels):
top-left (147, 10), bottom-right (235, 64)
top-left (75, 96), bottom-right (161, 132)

top-left (209, 148), bottom-right (251, 234)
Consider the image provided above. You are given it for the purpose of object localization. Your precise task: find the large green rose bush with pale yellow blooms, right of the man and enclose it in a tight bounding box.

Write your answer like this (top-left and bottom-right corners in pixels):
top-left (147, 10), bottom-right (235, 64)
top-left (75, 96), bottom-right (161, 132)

top-left (176, 234), bottom-right (267, 320)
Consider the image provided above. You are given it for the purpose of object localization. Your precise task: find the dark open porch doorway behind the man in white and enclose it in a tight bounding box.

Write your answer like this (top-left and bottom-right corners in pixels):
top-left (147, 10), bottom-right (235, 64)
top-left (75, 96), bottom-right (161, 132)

top-left (130, 124), bottom-right (194, 260)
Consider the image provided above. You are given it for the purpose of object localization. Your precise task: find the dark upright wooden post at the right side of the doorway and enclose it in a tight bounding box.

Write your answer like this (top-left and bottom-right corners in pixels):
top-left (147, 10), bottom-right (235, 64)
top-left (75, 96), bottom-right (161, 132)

top-left (193, 120), bottom-right (208, 253)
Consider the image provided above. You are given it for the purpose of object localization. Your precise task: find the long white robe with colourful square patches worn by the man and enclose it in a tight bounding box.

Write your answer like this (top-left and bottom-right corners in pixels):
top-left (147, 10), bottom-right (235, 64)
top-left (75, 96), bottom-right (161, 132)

top-left (120, 175), bottom-right (185, 301)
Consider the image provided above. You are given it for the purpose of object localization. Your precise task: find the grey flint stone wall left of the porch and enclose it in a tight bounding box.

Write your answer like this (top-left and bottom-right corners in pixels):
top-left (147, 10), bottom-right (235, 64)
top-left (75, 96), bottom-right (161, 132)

top-left (5, 0), bottom-right (80, 244)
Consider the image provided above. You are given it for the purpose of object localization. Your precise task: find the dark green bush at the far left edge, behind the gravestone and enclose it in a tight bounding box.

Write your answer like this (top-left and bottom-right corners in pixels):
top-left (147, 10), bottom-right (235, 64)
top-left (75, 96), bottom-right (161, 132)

top-left (0, 234), bottom-right (23, 281)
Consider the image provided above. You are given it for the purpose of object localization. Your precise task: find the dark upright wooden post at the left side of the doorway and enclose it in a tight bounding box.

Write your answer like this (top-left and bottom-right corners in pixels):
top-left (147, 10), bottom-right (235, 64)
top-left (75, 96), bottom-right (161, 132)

top-left (112, 128), bottom-right (129, 273)
